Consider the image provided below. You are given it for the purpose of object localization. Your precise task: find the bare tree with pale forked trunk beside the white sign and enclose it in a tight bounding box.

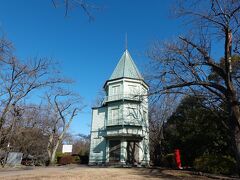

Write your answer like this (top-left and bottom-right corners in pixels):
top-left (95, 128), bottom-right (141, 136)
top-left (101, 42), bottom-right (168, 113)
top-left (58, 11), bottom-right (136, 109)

top-left (46, 90), bottom-right (83, 164)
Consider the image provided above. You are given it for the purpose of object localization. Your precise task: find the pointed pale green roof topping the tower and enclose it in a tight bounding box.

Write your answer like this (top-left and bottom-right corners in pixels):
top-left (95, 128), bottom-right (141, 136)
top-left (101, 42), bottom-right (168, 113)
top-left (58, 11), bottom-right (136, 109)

top-left (109, 50), bottom-right (143, 80)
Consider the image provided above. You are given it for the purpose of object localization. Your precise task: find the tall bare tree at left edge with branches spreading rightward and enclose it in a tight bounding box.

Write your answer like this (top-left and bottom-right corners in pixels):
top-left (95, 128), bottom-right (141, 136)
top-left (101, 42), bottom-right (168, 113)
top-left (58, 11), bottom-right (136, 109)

top-left (0, 38), bottom-right (68, 152)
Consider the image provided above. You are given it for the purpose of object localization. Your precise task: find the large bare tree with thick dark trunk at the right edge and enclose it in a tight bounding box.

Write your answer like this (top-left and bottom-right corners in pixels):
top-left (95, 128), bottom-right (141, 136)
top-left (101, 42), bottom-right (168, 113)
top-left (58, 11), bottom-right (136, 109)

top-left (149, 0), bottom-right (240, 172)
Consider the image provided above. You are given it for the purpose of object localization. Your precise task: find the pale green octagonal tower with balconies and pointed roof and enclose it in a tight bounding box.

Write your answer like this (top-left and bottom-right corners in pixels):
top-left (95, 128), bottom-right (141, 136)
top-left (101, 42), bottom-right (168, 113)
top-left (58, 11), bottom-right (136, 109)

top-left (89, 50), bottom-right (149, 165)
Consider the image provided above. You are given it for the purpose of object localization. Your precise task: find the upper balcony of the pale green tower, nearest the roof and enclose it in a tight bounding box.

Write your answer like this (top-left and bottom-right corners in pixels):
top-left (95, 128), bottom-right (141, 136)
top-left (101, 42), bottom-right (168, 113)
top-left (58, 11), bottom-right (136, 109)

top-left (103, 94), bottom-right (143, 104)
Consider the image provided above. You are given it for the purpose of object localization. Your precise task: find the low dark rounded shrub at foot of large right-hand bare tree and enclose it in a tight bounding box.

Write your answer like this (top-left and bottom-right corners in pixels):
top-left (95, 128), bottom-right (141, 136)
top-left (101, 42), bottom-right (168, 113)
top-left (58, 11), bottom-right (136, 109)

top-left (194, 155), bottom-right (236, 175)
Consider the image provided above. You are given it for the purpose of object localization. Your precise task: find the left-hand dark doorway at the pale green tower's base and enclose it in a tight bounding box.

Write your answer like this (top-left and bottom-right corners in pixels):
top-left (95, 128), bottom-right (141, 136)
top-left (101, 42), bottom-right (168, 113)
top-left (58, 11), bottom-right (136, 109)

top-left (109, 140), bottom-right (121, 163)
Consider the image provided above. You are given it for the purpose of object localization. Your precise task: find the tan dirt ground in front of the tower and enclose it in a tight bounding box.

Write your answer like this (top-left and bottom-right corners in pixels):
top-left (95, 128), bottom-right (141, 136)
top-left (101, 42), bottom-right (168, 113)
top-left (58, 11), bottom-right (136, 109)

top-left (0, 165), bottom-right (234, 180)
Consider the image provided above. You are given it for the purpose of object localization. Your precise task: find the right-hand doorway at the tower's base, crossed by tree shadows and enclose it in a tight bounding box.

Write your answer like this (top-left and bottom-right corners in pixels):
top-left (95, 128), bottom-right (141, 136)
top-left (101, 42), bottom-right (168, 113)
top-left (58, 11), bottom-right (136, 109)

top-left (127, 141), bottom-right (139, 164)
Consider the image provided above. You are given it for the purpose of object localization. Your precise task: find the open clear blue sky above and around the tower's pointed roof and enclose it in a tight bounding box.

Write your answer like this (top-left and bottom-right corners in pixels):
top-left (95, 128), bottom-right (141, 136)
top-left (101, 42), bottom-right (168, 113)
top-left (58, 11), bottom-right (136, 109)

top-left (0, 0), bottom-right (221, 134)
